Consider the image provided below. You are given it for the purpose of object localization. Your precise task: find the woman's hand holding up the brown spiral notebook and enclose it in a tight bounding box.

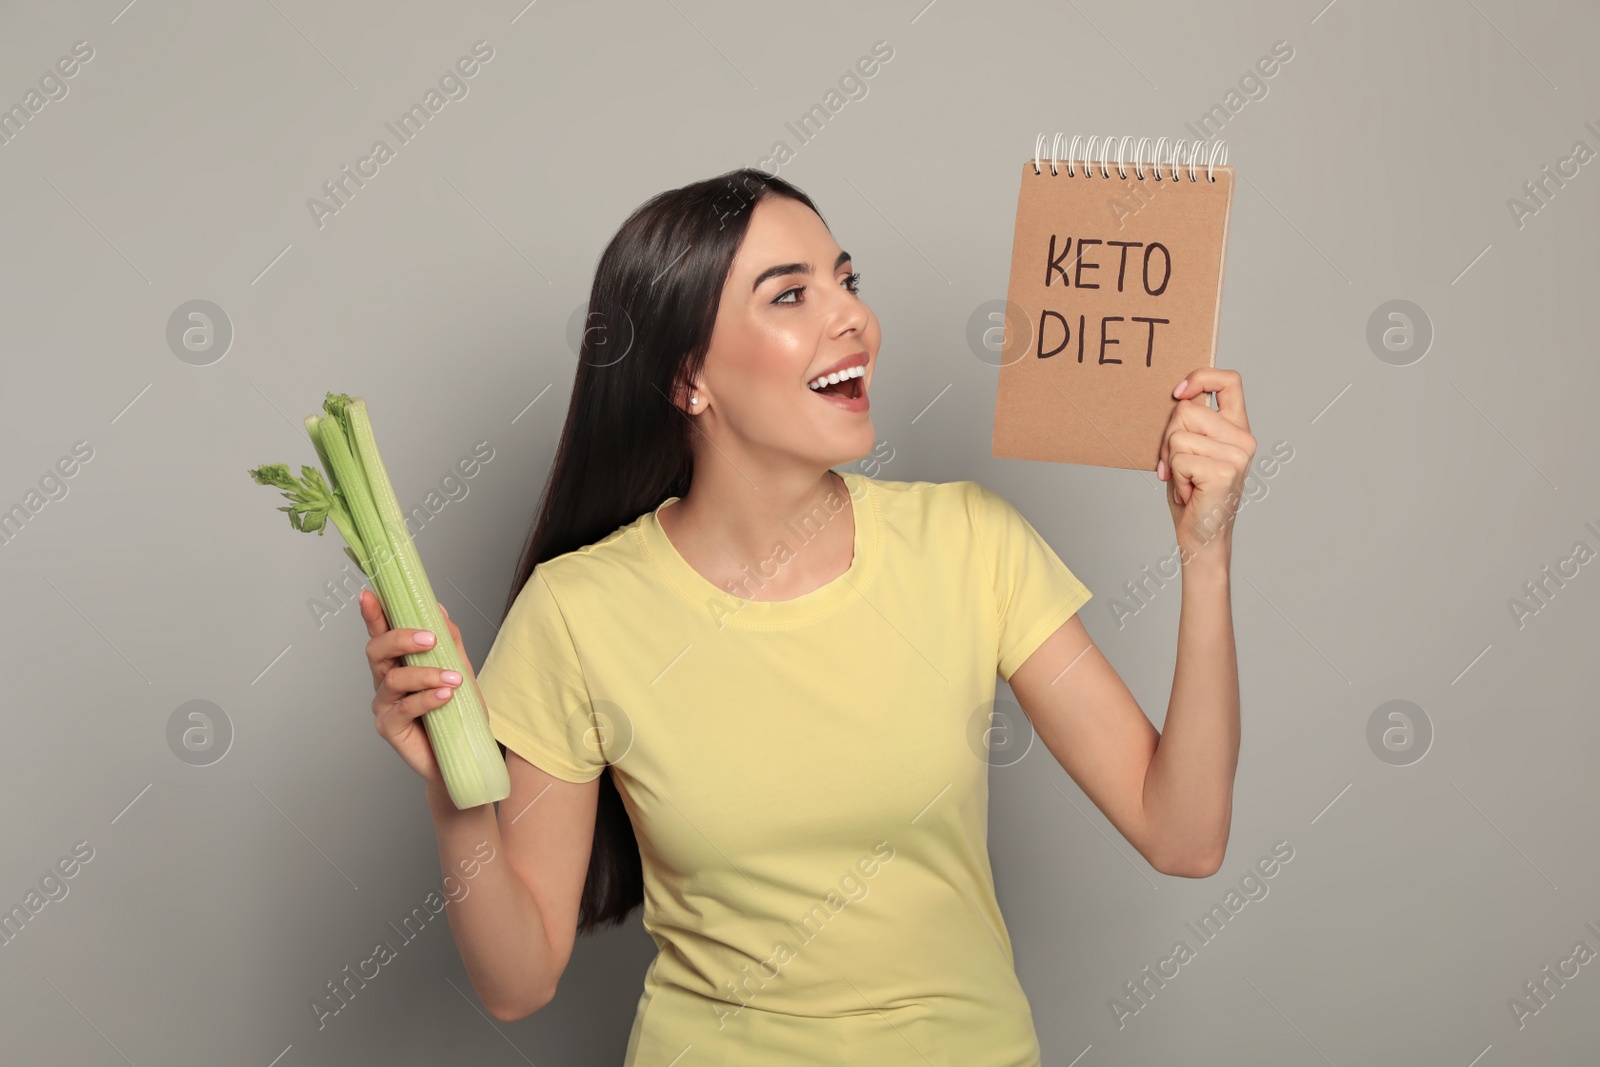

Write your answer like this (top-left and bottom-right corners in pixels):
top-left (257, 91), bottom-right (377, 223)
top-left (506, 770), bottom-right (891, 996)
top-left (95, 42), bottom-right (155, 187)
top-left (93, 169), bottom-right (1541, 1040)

top-left (1155, 366), bottom-right (1256, 563)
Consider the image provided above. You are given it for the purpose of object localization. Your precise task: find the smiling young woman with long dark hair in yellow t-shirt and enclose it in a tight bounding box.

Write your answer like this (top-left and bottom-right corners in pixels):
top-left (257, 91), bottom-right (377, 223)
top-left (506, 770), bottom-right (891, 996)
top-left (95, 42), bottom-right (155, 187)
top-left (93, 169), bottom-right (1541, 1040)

top-left (362, 170), bottom-right (1256, 1067)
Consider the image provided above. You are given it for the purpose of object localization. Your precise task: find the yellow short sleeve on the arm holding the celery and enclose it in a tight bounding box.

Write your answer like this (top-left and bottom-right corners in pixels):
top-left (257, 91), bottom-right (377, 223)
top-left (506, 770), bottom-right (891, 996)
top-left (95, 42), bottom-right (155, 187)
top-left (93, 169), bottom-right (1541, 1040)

top-left (477, 566), bottom-right (606, 782)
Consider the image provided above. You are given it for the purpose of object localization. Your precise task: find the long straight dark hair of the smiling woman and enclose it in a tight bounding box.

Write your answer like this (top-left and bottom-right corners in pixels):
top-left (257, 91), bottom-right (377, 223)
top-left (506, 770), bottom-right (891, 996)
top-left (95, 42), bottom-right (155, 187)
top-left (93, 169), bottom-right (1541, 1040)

top-left (501, 168), bottom-right (826, 933)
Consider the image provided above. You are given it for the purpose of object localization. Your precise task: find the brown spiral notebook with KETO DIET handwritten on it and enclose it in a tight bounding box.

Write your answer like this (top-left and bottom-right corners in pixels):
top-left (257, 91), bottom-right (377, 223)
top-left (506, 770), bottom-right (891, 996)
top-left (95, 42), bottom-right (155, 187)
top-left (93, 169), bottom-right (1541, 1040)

top-left (994, 134), bottom-right (1234, 470)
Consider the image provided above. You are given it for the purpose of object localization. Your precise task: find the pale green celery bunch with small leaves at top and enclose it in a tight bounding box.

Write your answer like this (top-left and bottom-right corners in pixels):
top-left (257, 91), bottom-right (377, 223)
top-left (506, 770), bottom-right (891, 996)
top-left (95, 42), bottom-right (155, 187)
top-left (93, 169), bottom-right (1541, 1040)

top-left (250, 392), bottom-right (510, 808)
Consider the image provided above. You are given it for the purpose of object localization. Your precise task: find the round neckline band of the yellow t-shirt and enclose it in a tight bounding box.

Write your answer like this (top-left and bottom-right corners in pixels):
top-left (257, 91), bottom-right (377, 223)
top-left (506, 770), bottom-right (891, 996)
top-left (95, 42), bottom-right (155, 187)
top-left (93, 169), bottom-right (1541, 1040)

top-left (637, 470), bottom-right (882, 629)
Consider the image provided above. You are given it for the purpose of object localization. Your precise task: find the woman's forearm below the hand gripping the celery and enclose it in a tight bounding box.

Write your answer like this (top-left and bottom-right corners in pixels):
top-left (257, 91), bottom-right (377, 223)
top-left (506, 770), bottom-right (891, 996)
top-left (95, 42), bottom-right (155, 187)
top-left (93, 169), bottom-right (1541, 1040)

top-left (427, 785), bottom-right (558, 1021)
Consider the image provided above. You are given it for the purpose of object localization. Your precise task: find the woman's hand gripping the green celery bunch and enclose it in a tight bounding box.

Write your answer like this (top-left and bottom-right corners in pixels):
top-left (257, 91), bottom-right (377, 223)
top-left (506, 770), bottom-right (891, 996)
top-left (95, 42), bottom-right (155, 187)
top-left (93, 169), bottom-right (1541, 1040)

top-left (358, 589), bottom-right (472, 787)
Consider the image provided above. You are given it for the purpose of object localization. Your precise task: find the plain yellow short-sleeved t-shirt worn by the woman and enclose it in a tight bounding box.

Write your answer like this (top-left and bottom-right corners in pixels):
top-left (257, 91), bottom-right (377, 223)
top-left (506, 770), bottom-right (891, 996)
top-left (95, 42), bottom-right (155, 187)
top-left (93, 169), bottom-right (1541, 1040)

top-left (478, 474), bottom-right (1090, 1067)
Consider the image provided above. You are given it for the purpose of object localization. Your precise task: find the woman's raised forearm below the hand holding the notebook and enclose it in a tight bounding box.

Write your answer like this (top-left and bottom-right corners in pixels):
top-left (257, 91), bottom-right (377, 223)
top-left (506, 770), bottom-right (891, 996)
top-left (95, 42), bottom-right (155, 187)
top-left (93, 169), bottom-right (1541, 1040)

top-left (1144, 544), bottom-right (1238, 875)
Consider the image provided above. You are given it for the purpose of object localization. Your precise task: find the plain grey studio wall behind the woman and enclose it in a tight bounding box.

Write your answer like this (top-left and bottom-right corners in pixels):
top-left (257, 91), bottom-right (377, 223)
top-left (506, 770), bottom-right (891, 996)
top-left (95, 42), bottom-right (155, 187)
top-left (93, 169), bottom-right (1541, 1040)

top-left (0, 0), bottom-right (1600, 1067)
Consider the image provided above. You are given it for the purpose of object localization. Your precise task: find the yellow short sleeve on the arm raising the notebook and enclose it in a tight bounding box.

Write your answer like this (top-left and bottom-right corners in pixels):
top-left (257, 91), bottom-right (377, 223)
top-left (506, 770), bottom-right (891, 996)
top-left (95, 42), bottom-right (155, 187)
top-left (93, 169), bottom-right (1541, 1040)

top-left (966, 482), bottom-right (1091, 681)
